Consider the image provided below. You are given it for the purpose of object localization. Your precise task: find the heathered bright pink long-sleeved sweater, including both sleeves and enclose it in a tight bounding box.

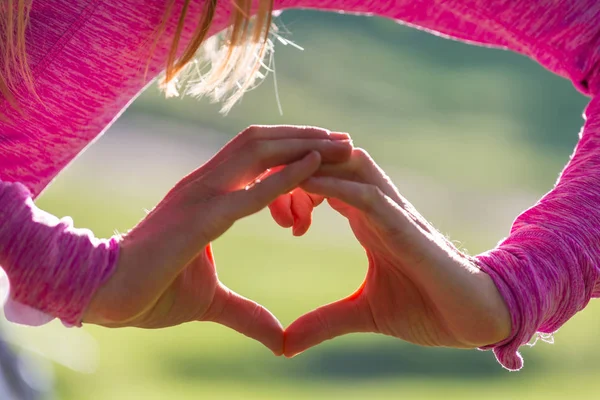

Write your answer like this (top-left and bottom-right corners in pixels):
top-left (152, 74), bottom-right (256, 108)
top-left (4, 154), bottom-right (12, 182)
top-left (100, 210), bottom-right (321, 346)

top-left (0, 0), bottom-right (600, 369)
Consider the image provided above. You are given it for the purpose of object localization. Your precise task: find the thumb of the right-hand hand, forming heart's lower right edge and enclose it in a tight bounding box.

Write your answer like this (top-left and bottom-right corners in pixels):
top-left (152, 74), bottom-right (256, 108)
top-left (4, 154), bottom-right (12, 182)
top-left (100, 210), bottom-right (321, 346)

top-left (283, 297), bottom-right (375, 357)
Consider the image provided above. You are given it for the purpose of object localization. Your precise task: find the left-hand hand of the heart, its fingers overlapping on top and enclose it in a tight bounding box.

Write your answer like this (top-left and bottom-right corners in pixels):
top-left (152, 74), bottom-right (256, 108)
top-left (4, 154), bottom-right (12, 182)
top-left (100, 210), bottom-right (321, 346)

top-left (84, 126), bottom-right (352, 355)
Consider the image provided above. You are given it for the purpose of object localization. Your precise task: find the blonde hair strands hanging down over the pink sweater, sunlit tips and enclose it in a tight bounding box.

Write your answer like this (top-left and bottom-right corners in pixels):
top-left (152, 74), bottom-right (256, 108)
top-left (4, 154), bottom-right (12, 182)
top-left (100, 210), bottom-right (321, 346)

top-left (0, 0), bottom-right (273, 112)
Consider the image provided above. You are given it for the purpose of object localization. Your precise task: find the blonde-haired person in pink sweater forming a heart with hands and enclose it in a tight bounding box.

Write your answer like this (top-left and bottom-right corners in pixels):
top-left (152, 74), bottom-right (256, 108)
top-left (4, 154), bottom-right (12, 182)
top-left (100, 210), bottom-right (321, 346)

top-left (0, 0), bottom-right (600, 370)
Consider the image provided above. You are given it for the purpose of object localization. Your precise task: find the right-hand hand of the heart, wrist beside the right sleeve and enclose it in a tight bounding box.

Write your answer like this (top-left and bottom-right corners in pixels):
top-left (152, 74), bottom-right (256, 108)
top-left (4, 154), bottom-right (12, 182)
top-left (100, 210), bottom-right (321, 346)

top-left (284, 149), bottom-right (511, 357)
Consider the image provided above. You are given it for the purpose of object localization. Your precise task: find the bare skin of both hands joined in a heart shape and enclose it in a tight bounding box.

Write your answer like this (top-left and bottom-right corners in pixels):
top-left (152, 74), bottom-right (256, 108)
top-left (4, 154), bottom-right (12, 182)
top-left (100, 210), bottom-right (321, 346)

top-left (84, 126), bottom-right (511, 357)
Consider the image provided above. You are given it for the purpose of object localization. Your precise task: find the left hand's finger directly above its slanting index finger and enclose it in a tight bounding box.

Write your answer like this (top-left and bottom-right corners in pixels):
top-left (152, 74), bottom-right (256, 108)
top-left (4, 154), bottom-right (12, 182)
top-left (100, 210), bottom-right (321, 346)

top-left (209, 139), bottom-right (352, 192)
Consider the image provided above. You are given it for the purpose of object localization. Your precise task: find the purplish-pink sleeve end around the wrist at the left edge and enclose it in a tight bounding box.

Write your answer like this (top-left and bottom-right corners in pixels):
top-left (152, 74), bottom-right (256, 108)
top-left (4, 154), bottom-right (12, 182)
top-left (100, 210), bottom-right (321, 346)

top-left (0, 181), bottom-right (119, 326)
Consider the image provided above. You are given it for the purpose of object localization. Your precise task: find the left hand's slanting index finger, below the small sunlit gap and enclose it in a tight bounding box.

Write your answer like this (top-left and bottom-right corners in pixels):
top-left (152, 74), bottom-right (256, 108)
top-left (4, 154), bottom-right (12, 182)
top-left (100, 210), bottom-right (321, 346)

top-left (221, 151), bottom-right (321, 222)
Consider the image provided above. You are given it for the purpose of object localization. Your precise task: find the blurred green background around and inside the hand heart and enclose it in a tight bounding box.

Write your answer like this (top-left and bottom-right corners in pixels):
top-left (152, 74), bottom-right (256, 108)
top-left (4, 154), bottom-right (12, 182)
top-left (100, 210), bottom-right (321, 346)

top-left (6, 11), bottom-right (600, 400)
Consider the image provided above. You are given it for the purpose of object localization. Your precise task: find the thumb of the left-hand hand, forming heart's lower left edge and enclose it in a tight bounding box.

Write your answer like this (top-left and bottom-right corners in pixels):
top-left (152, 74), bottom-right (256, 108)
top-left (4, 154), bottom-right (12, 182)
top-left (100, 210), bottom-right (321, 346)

top-left (203, 285), bottom-right (283, 356)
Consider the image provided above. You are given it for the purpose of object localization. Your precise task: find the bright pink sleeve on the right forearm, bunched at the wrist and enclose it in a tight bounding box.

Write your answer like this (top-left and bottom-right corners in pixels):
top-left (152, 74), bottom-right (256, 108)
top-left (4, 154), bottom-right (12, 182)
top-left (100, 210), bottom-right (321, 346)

top-left (474, 98), bottom-right (600, 370)
